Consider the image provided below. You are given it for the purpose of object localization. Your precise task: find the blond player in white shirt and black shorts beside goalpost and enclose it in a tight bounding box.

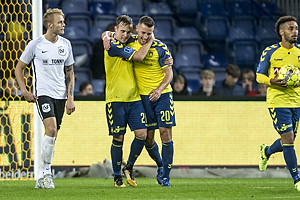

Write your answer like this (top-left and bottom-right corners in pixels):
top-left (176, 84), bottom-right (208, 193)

top-left (15, 8), bottom-right (75, 188)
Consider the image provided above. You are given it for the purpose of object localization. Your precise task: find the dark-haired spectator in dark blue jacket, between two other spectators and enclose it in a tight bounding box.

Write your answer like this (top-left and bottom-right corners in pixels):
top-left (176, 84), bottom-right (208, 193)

top-left (217, 64), bottom-right (246, 96)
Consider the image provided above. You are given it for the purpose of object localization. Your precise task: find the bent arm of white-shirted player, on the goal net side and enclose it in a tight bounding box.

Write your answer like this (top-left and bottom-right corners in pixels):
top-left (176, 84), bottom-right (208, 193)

top-left (15, 60), bottom-right (37, 102)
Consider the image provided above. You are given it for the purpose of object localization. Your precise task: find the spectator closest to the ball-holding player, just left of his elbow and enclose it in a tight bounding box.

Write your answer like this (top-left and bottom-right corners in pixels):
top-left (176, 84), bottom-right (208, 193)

top-left (242, 69), bottom-right (259, 96)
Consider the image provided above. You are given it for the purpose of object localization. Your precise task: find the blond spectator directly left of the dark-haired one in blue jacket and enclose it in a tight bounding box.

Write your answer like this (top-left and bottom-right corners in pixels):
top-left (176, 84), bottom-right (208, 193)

top-left (193, 69), bottom-right (218, 97)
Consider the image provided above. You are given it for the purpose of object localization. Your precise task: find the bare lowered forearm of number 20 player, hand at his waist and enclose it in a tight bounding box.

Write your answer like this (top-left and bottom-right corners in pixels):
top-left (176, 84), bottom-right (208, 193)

top-left (149, 66), bottom-right (173, 101)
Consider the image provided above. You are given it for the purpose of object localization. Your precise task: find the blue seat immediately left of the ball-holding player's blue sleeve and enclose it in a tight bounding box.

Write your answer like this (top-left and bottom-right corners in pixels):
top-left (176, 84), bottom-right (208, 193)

top-left (233, 41), bottom-right (258, 69)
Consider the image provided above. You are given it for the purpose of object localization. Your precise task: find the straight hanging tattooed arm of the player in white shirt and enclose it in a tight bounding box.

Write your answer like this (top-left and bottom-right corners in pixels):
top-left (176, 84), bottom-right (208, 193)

top-left (65, 65), bottom-right (75, 115)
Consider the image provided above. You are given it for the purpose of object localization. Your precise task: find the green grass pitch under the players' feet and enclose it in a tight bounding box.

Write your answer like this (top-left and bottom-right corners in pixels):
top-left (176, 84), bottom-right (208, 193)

top-left (0, 178), bottom-right (300, 200)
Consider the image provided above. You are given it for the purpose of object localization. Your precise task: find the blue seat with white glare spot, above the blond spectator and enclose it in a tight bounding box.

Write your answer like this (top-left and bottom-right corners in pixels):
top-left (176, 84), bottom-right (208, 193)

top-left (202, 53), bottom-right (228, 71)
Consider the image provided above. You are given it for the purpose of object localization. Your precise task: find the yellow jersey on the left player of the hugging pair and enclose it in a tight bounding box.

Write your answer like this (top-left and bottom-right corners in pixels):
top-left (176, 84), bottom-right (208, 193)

top-left (104, 40), bottom-right (141, 103)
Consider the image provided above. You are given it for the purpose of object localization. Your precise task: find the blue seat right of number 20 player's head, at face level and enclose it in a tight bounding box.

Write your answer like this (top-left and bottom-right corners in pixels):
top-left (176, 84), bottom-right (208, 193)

top-left (173, 27), bottom-right (201, 43)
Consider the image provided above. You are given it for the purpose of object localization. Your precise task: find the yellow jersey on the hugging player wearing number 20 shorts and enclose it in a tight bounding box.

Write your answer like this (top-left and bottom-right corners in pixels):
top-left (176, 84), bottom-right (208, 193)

top-left (127, 35), bottom-right (172, 95)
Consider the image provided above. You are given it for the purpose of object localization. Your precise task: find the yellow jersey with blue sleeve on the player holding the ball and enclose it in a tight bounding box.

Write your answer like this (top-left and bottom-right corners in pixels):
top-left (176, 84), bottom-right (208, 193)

top-left (256, 42), bottom-right (300, 108)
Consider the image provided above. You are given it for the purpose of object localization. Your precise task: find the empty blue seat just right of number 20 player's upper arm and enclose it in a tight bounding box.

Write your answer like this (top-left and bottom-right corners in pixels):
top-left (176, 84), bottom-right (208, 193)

top-left (173, 53), bottom-right (203, 72)
